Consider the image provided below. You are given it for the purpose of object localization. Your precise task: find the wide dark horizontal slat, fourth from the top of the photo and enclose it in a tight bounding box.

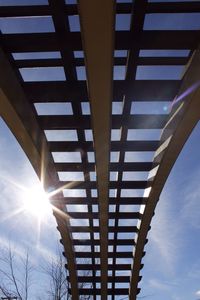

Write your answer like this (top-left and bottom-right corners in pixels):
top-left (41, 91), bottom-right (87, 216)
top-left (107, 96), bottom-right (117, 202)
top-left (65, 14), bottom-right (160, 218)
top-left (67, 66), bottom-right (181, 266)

top-left (23, 80), bottom-right (180, 103)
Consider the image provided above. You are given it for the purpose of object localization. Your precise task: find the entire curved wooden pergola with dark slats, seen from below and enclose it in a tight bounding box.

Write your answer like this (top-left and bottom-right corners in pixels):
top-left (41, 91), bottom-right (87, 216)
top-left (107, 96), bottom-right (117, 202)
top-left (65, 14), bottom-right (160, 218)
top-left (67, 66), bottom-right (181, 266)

top-left (0, 0), bottom-right (200, 300)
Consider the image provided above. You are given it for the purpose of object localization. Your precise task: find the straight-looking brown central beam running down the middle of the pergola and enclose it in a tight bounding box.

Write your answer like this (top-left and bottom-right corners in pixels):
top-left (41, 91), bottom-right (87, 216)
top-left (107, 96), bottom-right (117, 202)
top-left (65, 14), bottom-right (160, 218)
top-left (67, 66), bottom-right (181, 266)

top-left (79, 0), bottom-right (115, 300)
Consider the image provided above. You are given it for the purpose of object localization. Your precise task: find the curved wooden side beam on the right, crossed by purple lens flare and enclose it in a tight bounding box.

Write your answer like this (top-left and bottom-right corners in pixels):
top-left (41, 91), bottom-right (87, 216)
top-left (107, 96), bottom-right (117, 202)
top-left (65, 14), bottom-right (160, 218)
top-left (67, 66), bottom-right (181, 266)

top-left (129, 49), bottom-right (200, 300)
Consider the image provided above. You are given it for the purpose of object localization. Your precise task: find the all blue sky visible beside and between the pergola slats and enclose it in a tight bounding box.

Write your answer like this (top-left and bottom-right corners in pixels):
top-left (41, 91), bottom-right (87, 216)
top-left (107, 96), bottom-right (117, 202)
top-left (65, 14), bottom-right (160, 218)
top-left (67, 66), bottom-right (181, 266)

top-left (0, 0), bottom-right (200, 300)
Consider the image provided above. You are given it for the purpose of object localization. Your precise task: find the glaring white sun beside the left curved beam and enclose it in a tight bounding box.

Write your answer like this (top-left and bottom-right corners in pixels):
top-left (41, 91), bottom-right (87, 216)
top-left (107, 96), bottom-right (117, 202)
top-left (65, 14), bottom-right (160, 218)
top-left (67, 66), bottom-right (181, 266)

top-left (23, 184), bottom-right (51, 219)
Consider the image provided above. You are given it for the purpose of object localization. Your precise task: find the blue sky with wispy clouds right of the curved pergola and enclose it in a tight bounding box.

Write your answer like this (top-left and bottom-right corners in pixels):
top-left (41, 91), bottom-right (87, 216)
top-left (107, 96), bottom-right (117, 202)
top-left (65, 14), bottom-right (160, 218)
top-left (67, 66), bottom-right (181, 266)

top-left (141, 123), bottom-right (200, 300)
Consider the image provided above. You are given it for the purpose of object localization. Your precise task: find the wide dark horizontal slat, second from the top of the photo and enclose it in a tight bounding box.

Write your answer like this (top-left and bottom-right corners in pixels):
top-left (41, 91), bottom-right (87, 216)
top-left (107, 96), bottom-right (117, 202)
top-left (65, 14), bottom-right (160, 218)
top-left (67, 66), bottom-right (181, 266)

top-left (2, 30), bottom-right (200, 52)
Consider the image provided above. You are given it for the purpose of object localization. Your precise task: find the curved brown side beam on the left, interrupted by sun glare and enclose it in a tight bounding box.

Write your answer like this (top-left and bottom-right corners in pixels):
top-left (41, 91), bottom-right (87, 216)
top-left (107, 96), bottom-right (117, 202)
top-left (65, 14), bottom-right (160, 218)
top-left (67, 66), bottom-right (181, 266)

top-left (0, 49), bottom-right (78, 300)
